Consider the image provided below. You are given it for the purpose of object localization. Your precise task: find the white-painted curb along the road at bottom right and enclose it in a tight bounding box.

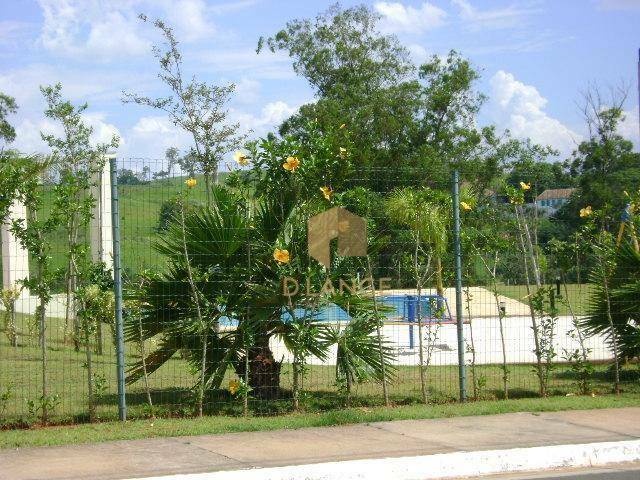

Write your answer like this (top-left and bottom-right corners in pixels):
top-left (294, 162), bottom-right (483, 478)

top-left (132, 440), bottom-right (640, 480)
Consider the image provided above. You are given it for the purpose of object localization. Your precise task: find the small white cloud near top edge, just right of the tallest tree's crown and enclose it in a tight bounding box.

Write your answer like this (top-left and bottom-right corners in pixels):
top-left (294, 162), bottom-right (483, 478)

top-left (374, 2), bottom-right (447, 33)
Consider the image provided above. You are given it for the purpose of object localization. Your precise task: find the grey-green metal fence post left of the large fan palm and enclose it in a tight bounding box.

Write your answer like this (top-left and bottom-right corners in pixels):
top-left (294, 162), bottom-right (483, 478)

top-left (109, 157), bottom-right (127, 421)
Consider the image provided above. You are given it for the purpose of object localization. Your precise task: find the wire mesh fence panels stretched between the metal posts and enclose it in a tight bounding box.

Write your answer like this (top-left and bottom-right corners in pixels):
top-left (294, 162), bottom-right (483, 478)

top-left (0, 157), bottom-right (639, 425)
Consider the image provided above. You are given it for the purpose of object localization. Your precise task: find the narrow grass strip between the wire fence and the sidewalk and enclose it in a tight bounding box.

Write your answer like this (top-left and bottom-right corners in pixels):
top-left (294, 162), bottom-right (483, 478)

top-left (0, 394), bottom-right (640, 448)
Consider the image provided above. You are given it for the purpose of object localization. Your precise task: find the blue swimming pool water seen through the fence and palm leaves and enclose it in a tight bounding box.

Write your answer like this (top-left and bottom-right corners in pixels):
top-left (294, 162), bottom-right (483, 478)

top-left (220, 295), bottom-right (451, 327)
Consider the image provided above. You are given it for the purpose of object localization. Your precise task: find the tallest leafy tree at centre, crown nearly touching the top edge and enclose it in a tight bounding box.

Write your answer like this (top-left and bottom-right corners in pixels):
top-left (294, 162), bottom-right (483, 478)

top-left (258, 5), bottom-right (417, 191)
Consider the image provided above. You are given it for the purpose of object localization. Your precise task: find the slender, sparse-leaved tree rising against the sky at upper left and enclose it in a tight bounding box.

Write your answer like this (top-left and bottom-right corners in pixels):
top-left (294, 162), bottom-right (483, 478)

top-left (123, 15), bottom-right (244, 198)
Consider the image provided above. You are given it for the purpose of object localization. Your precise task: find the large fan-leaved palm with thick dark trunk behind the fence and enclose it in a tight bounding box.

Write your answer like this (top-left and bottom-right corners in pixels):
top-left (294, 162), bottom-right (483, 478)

top-left (125, 186), bottom-right (396, 399)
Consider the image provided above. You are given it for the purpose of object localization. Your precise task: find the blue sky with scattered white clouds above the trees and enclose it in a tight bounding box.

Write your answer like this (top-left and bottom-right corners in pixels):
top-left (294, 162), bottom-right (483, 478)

top-left (0, 0), bottom-right (640, 166)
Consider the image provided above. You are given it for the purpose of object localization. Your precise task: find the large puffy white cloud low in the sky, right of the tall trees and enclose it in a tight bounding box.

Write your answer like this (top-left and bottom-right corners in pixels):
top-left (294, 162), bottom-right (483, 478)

top-left (490, 70), bottom-right (581, 155)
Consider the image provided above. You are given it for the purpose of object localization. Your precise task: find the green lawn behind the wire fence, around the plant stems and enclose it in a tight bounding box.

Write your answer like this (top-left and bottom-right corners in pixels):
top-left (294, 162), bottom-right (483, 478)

top-left (0, 308), bottom-right (640, 425)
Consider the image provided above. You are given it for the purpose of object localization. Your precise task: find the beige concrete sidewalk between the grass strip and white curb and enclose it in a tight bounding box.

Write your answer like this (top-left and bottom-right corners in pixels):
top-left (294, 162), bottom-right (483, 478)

top-left (0, 408), bottom-right (640, 480)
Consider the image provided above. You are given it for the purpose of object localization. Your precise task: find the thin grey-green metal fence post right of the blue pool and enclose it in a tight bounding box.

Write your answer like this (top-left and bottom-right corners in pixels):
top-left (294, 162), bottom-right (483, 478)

top-left (452, 170), bottom-right (467, 402)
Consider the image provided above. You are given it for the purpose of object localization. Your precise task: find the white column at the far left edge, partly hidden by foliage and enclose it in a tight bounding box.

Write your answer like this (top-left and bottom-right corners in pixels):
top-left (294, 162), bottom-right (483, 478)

top-left (0, 202), bottom-right (29, 296)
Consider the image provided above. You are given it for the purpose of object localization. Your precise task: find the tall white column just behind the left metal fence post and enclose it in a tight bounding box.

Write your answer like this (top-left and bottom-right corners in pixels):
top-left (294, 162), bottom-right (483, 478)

top-left (90, 154), bottom-right (115, 271)
